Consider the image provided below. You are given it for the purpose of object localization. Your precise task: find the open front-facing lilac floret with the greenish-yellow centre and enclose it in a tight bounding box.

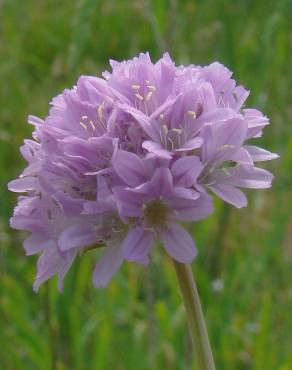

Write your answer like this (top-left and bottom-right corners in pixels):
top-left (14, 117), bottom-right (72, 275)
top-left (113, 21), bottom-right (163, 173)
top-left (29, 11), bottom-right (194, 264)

top-left (113, 151), bottom-right (212, 263)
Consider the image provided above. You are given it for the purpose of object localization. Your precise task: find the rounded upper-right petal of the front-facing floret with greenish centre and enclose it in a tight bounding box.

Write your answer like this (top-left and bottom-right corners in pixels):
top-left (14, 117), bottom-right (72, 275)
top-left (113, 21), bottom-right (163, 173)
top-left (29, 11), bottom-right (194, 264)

top-left (171, 156), bottom-right (203, 188)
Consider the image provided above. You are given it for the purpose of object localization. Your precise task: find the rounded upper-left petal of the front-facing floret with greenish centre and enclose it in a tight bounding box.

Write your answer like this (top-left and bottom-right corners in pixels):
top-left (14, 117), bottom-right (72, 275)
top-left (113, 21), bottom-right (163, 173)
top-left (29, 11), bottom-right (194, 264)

top-left (112, 150), bottom-right (146, 186)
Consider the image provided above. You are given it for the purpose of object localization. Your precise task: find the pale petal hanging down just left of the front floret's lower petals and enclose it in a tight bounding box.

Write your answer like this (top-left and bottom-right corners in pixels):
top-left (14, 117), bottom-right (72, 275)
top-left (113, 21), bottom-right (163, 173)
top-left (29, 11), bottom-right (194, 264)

top-left (93, 245), bottom-right (124, 288)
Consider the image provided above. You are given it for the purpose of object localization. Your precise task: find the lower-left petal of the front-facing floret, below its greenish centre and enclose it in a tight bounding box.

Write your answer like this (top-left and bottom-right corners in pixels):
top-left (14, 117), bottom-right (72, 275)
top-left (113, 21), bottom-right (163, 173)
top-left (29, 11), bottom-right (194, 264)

top-left (121, 227), bottom-right (154, 261)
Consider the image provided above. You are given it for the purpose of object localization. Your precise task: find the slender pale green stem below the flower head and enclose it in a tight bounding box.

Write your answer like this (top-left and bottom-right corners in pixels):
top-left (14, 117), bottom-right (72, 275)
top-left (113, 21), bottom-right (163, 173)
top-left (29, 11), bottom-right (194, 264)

top-left (173, 260), bottom-right (216, 370)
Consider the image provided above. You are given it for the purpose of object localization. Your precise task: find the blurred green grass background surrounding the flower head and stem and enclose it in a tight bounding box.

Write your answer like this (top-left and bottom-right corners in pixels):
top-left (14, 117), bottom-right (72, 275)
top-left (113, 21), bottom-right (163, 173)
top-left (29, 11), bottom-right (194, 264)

top-left (0, 0), bottom-right (292, 370)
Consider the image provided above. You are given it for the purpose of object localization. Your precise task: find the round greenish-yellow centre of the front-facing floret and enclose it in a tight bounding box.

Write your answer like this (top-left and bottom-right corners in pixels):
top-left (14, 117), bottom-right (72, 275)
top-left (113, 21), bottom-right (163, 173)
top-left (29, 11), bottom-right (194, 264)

top-left (143, 199), bottom-right (169, 227)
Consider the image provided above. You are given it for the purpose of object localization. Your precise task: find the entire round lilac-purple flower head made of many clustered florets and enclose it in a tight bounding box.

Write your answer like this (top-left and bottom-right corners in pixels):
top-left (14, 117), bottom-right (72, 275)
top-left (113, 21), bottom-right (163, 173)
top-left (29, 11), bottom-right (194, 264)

top-left (9, 54), bottom-right (277, 290)
